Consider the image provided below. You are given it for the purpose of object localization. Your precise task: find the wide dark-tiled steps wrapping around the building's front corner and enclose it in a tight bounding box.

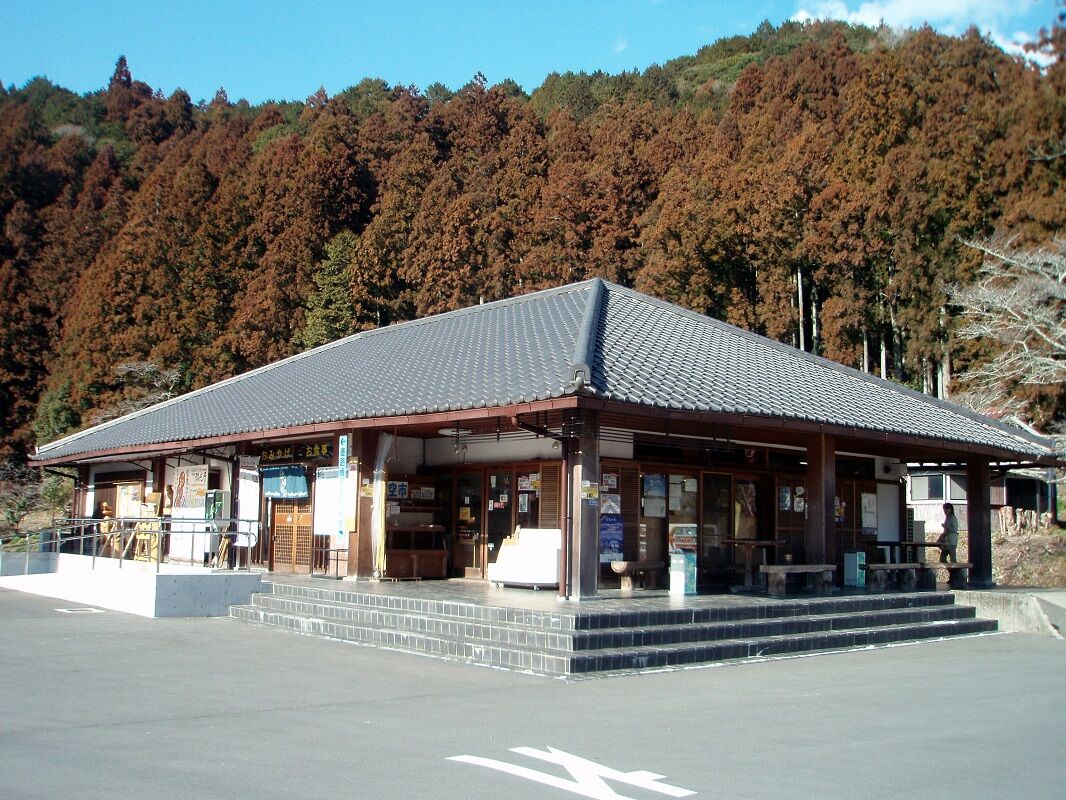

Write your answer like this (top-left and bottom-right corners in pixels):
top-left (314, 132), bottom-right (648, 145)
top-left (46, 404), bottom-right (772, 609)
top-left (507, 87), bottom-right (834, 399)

top-left (230, 580), bottom-right (997, 676)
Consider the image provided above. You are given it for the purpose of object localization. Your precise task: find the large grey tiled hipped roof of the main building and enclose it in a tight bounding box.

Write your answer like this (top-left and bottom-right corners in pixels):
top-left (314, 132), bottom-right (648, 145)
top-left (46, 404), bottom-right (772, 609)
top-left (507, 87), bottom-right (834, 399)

top-left (37, 281), bottom-right (1049, 459)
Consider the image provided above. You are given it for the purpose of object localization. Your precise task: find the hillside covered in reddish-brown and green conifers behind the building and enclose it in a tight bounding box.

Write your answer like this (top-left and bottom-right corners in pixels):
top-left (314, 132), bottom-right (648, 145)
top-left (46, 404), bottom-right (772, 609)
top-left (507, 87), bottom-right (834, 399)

top-left (0, 18), bottom-right (1066, 454)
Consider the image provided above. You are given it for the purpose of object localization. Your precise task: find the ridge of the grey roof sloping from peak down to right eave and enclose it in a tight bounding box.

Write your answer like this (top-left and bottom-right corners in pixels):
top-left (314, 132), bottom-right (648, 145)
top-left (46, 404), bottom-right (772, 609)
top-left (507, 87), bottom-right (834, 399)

top-left (608, 282), bottom-right (1053, 449)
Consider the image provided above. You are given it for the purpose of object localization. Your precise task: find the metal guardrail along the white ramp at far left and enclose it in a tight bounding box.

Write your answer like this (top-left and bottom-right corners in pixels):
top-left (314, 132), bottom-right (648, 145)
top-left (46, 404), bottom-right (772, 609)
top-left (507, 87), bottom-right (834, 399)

top-left (0, 516), bottom-right (261, 573)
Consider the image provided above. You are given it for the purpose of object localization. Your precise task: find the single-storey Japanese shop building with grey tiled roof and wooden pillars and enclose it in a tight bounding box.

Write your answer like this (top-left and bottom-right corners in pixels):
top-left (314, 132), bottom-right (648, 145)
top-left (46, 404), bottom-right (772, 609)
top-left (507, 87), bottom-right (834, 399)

top-left (35, 279), bottom-right (1055, 596)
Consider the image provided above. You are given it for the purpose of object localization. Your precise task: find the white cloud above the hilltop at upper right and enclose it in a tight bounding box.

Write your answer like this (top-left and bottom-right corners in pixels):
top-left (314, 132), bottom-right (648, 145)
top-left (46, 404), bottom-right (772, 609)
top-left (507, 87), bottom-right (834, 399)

top-left (792, 0), bottom-right (1048, 60)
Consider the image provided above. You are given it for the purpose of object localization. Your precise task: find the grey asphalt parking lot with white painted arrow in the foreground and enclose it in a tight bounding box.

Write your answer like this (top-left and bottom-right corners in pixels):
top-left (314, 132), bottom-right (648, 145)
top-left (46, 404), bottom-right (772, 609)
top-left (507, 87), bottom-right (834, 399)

top-left (0, 590), bottom-right (1066, 800)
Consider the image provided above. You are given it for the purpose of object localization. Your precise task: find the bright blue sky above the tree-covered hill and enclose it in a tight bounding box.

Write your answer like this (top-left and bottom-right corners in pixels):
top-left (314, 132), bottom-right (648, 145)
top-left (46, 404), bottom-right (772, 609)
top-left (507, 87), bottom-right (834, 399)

top-left (0, 0), bottom-right (1061, 103)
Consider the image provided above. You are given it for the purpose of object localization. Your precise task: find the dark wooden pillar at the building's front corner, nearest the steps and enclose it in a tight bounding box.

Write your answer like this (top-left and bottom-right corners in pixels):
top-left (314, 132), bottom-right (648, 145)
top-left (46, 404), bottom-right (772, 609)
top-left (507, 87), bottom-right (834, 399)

top-left (568, 413), bottom-right (600, 599)
